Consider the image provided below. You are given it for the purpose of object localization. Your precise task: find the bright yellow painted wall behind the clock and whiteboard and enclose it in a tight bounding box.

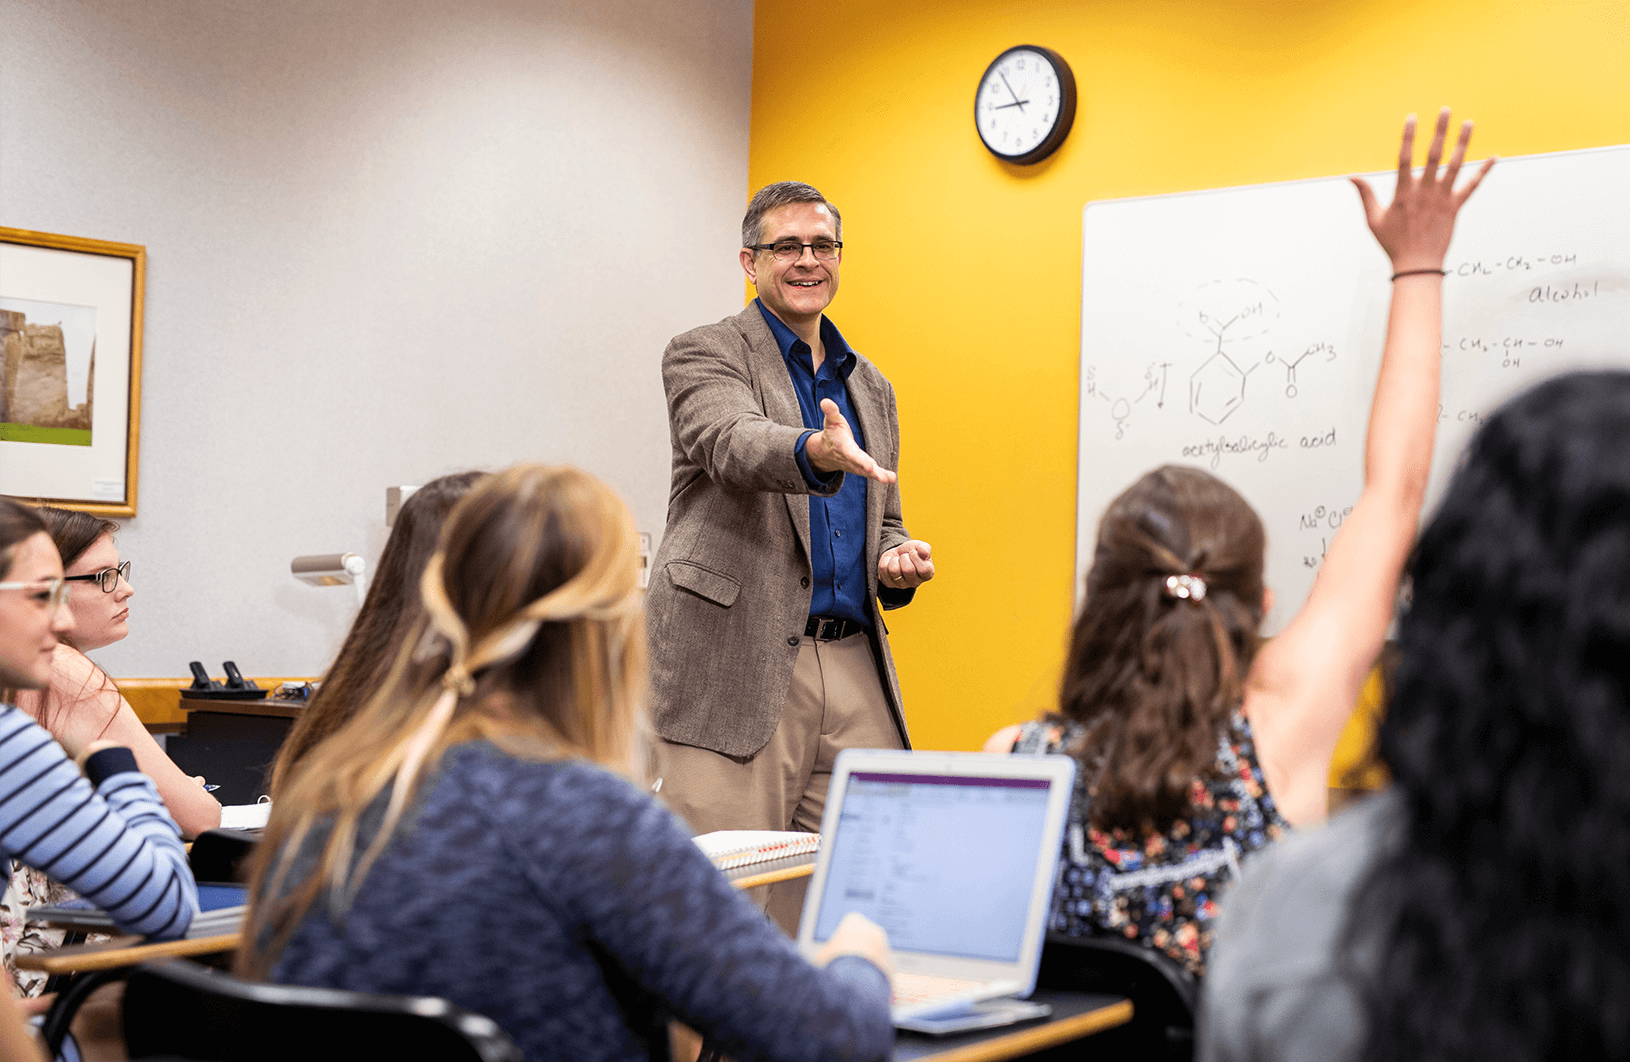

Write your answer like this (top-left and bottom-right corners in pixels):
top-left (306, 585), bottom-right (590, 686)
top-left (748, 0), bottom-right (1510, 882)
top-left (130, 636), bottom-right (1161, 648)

top-left (748, 0), bottom-right (1630, 748)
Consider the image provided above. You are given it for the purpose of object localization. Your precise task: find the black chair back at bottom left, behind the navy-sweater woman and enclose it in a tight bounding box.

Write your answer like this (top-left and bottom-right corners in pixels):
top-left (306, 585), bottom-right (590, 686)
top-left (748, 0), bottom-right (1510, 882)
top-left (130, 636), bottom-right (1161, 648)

top-left (124, 959), bottom-right (522, 1062)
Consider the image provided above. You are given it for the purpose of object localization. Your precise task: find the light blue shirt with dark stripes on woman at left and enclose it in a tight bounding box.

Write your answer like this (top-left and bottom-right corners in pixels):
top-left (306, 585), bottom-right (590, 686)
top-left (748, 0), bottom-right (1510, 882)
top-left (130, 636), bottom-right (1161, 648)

top-left (0, 705), bottom-right (199, 940)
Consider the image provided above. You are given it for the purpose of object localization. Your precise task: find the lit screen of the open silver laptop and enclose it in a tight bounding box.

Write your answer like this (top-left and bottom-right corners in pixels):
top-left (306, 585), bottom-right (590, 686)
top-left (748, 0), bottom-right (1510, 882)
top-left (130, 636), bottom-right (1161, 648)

top-left (813, 770), bottom-right (1048, 963)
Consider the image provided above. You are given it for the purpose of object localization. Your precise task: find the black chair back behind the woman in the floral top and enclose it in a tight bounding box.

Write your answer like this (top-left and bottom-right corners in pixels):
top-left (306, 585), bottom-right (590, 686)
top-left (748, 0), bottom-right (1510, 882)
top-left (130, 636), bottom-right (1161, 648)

top-left (1037, 933), bottom-right (1200, 1062)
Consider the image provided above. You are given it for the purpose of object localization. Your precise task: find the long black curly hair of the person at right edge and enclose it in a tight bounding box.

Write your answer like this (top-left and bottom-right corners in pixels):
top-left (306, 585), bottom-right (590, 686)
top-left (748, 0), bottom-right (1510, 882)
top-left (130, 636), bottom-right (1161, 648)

top-left (1343, 371), bottom-right (1630, 1062)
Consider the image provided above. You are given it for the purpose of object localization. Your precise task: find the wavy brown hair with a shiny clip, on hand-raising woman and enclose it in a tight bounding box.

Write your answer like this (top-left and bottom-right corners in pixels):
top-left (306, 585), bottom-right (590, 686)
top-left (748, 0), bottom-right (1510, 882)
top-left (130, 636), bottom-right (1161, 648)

top-left (1060, 464), bottom-right (1267, 831)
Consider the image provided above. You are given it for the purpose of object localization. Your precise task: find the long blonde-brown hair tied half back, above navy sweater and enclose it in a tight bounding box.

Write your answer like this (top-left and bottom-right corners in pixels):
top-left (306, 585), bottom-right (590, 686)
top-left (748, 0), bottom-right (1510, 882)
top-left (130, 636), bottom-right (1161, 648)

top-left (238, 464), bottom-right (645, 977)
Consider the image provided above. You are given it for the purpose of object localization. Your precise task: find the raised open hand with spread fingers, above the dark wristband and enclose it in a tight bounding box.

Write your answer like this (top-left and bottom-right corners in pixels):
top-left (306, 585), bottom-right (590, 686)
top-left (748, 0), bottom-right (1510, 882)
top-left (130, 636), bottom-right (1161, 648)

top-left (1353, 108), bottom-right (1495, 272)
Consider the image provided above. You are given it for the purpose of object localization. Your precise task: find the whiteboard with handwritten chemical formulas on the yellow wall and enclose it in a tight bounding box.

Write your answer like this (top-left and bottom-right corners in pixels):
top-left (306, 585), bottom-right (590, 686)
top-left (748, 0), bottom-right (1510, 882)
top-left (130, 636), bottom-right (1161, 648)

top-left (1076, 147), bottom-right (1630, 634)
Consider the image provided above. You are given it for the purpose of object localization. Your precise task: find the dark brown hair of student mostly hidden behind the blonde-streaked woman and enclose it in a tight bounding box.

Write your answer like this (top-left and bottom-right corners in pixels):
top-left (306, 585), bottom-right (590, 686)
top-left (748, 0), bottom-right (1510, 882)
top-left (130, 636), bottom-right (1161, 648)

top-left (267, 472), bottom-right (486, 800)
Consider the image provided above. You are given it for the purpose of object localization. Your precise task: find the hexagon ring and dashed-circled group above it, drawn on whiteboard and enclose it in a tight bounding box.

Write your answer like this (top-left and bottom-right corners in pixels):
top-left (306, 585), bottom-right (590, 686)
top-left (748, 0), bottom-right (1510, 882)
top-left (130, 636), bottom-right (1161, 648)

top-left (1177, 277), bottom-right (1280, 423)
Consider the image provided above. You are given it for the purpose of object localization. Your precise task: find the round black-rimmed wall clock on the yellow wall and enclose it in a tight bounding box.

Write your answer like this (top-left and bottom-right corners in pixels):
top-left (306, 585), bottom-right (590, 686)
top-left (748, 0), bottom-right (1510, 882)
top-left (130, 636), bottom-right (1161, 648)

top-left (973, 44), bottom-right (1076, 166)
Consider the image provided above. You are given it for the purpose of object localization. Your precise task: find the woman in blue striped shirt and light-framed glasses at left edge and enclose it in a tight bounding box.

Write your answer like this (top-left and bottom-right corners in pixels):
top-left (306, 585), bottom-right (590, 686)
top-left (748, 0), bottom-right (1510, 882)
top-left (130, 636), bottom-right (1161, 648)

top-left (0, 498), bottom-right (197, 985)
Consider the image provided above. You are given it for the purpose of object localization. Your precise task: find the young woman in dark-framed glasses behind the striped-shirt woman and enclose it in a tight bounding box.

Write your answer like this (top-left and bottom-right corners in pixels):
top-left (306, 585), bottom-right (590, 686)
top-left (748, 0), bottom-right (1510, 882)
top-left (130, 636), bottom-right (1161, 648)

top-left (16, 505), bottom-right (220, 837)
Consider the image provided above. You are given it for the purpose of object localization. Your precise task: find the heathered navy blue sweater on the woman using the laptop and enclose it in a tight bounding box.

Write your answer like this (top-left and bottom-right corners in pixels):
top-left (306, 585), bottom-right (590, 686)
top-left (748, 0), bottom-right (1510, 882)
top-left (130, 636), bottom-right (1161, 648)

top-left (272, 743), bottom-right (893, 1062)
